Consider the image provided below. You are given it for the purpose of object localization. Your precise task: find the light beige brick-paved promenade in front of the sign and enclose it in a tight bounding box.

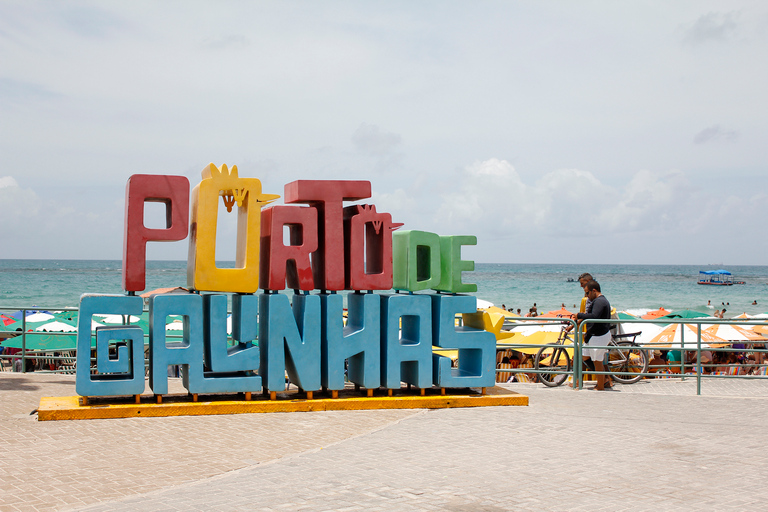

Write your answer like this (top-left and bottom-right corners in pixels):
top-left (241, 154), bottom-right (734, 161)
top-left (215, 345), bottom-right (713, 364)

top-left (0, 373), bottom-right (768, 511)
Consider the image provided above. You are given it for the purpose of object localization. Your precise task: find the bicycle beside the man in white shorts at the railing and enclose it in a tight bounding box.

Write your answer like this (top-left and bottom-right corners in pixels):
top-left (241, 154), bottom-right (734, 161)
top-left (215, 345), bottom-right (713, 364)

top-left (533, 327), bottom-right (648, 387)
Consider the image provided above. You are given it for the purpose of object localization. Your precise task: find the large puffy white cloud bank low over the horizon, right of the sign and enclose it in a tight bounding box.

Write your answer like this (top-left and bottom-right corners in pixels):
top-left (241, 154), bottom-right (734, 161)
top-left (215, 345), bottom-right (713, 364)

top-left (433, 158), bottom-right (758, 240)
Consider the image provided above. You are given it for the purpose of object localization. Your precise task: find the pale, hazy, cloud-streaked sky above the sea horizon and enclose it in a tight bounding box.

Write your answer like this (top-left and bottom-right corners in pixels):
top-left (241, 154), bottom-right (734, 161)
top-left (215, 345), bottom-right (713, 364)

top-left (0, 0), bottom-right (768, 265)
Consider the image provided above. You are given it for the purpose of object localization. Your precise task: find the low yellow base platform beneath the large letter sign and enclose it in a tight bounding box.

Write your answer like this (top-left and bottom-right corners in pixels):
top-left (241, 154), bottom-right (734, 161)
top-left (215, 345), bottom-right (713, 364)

top-left (37, 387), bottom-right (528, 421)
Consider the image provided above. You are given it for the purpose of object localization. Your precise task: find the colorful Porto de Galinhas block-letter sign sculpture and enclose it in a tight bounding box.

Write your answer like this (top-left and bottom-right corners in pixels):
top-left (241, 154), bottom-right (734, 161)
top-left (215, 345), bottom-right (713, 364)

top-left (76, 164), bottom-right (495, 396)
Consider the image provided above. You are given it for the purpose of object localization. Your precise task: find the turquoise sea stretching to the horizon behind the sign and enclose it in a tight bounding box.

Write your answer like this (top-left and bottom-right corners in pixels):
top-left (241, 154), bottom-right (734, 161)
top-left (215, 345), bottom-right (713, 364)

top-left (0, 260), bottom-right (768, 317)
